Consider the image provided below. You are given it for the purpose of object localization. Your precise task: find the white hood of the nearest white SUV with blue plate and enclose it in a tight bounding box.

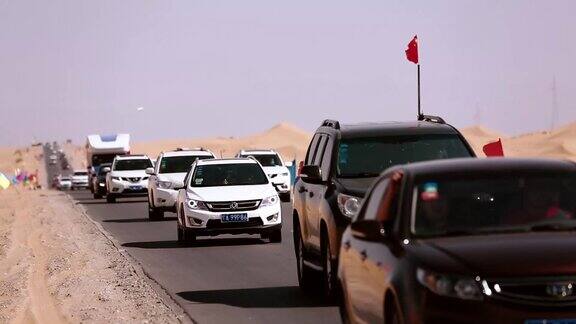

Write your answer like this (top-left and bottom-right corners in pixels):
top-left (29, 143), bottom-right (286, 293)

top-left (187, 184), bottom-right (276, 202)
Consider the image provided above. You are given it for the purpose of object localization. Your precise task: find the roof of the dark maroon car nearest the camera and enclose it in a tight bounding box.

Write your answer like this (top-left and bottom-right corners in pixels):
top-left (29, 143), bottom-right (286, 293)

top-left (383, 157), bottom-right (576, 177)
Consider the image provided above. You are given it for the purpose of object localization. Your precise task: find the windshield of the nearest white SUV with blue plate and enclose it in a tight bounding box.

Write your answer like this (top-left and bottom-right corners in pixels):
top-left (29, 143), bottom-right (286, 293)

top-left (190, 163), bottom-right (268, 187)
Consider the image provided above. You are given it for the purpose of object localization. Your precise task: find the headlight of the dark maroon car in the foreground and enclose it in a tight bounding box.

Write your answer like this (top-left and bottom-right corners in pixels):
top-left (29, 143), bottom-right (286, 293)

top-left (416, 269), bottom-right (484, 300)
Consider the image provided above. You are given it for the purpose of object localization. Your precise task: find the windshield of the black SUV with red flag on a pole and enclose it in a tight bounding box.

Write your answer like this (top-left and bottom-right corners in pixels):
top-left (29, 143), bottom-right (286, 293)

top-left (338, 134), bottom-right (470, 178)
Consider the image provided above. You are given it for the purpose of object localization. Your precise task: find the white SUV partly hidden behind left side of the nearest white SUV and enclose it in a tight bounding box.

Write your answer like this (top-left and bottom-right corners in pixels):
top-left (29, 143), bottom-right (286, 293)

top-left (146, 148), bottom-right (214, 220)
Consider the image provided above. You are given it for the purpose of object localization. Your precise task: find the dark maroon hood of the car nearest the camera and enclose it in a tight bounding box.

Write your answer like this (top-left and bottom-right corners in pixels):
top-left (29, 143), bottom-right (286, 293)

top-left (408, 232), bottom-right (576, 277)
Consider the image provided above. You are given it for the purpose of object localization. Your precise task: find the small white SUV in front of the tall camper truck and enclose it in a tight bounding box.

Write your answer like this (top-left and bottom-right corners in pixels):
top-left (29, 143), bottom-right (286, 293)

top-left (106, 155), bottom-right (152, 203)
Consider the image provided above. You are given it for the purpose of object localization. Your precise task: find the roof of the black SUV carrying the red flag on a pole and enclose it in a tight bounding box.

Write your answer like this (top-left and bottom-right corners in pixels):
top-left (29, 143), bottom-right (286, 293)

top-left (332, 121), bottom-right (459, 138)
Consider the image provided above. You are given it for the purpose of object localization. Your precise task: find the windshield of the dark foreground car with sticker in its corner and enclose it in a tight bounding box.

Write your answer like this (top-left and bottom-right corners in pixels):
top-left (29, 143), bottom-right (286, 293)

top-left (412, 174), bottom-right (576, 236)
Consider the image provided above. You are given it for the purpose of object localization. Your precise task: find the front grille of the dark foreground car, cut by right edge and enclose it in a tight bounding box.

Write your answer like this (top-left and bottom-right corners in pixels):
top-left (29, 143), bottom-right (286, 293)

top-left (490, 277), bottom-right (576, 306)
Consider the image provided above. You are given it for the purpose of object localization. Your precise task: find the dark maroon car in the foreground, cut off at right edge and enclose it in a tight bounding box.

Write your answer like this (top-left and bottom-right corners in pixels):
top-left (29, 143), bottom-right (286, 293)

top-left (338, 158), bottom-right (576, 323)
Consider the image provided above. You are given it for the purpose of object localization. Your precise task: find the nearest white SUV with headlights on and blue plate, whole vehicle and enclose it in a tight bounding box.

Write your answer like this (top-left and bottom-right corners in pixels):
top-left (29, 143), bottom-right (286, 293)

top-left (176, 159), bottom-right (282, 242)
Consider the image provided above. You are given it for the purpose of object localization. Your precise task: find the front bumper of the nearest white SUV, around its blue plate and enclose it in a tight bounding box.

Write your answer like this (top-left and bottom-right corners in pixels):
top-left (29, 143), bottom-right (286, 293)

top-left (183, 203), bottom-right (282, 235)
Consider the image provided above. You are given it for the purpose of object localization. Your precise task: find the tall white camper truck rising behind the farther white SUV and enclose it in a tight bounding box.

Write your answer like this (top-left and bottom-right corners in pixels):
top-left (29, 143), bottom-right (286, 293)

top-left (86, 134), bottom-right (130, 197)
